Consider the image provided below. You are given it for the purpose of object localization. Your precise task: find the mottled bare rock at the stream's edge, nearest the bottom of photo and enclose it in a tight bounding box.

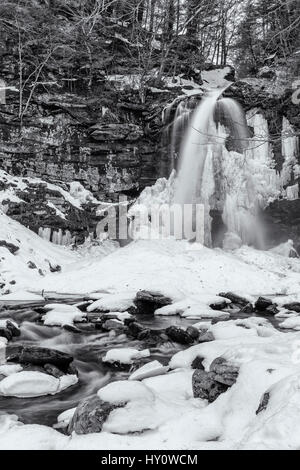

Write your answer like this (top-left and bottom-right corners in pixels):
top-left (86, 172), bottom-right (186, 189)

top-left (68, 396), bottom-right (126, 434)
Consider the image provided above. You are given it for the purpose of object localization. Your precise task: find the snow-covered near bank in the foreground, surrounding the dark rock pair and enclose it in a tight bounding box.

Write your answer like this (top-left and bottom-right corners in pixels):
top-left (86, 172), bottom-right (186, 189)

top-left (0, 318), bottom-right (300, 450)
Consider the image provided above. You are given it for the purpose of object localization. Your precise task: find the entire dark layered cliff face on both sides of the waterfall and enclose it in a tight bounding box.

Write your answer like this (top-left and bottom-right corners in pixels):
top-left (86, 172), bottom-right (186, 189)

top-left (0, 62), bottom-right (300, 250)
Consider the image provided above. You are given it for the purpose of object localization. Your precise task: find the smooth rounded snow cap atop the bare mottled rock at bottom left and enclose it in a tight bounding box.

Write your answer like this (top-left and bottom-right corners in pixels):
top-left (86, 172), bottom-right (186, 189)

top-left (97, 380), bottom-right (154, 404)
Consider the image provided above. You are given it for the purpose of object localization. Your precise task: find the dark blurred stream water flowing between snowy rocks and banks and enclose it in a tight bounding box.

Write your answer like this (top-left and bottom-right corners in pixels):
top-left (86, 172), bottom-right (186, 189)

top-left (0, 301), bottom-right (288, 426)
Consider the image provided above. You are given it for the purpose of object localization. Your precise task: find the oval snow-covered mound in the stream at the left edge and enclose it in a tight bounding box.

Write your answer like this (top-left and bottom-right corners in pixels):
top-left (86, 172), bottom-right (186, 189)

top-left (0, 371), bottom-right (78, 398)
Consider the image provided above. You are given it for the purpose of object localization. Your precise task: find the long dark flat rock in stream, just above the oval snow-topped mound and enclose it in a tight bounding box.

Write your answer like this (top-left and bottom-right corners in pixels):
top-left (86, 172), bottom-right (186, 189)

top-left (7, 346), bottom-right (73, 372)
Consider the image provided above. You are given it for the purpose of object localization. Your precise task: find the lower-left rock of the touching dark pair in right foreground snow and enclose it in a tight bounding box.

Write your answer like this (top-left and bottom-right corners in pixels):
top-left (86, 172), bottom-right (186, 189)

top-left (192, 369), bottom-right (229, 403)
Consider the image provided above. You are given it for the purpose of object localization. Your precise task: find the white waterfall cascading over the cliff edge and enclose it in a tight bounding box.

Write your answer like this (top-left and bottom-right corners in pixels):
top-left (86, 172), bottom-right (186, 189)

top-left (174, 89), bottom-right (272, 248)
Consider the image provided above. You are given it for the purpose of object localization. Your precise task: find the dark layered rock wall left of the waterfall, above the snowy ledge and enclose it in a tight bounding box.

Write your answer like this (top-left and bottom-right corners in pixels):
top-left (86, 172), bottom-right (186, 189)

top-left (0, 85), bottom-right (170, 199)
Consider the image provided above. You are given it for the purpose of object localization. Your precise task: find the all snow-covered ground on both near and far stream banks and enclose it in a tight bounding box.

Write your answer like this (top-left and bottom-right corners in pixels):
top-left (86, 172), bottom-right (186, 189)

top-left (0, 194), bottom-right (300, 449)
